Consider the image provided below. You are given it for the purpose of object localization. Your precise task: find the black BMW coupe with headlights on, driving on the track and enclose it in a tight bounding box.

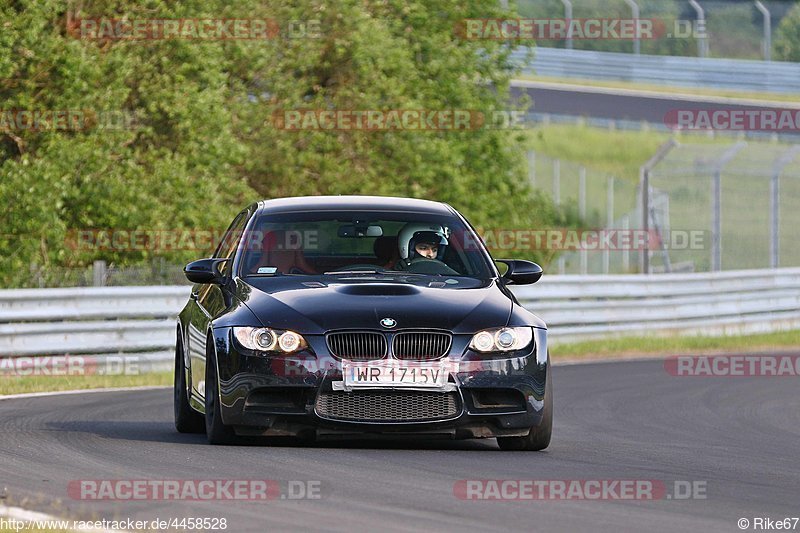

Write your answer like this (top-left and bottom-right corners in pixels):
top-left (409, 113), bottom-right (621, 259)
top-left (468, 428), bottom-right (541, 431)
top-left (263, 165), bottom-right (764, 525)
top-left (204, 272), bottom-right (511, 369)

top-left (174, 196), bottom-right (553, 450)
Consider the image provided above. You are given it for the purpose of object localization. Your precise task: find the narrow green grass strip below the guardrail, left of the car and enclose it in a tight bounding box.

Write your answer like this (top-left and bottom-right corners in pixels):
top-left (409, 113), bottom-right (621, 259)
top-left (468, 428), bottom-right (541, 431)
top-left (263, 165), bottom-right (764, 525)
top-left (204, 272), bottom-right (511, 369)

top-left (0, 372), bottom-right (172, 396)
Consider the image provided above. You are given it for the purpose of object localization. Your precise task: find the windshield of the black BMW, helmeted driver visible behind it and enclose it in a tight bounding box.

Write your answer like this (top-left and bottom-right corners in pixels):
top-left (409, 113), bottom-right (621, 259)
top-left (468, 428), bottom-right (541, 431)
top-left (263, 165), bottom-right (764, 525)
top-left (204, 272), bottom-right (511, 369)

top-left (239, 211), bottom-right (494, 285)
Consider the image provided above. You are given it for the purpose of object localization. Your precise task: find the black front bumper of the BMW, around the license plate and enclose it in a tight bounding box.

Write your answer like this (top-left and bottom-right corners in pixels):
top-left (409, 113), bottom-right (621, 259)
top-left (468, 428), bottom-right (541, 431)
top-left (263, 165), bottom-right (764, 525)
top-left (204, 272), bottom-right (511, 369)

top-left (209, 328), bottom-right (549, 438)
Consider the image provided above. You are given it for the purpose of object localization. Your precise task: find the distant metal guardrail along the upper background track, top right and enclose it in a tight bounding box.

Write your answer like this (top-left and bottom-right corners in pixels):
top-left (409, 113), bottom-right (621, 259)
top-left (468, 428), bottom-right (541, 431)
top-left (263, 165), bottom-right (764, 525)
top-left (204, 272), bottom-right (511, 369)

top-left (513, 47), bottom-right (800, 93)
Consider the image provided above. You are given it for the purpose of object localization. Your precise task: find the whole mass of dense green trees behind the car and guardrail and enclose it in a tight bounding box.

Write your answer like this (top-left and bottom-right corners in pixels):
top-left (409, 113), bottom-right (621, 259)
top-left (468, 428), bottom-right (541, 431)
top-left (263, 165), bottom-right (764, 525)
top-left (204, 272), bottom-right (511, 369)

top-left (0, 0), bottom-right (558, 286)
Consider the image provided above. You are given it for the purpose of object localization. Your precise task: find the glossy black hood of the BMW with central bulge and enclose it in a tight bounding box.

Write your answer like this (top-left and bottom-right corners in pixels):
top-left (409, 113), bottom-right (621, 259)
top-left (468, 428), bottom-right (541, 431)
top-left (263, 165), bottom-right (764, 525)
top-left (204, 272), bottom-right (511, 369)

top-left (237, 278), bottom-right (513, 334)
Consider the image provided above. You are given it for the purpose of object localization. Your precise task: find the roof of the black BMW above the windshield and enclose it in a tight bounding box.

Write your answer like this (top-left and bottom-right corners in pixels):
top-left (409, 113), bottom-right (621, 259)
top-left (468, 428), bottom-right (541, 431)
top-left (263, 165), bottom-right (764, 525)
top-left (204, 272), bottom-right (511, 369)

top-left (258, 195), bottom-right (454, 215)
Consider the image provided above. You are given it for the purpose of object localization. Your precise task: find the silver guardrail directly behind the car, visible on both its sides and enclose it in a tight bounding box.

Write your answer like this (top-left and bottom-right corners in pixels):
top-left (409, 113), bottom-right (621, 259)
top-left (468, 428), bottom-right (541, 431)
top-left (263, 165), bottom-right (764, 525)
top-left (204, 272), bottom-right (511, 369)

top-left (0, 268), bottom-right (800, 371)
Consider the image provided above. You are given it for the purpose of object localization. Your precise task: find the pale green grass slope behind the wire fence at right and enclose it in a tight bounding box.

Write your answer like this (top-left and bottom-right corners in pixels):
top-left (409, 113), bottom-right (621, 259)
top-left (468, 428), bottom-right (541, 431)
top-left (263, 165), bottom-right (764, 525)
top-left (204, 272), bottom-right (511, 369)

top-left (527, 124), bottom-right (800, 271)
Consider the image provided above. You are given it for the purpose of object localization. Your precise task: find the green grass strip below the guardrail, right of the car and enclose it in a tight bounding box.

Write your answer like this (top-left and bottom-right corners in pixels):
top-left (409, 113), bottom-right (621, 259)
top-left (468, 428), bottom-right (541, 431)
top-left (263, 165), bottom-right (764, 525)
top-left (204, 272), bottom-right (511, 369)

top-left (550, 330), bottom-right (800, 361)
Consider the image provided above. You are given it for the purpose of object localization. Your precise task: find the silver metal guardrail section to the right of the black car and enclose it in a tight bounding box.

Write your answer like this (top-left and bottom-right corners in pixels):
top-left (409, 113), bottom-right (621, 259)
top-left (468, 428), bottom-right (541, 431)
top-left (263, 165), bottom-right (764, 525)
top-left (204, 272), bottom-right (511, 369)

top-left (514, 268), bottom-right (800, 343)
